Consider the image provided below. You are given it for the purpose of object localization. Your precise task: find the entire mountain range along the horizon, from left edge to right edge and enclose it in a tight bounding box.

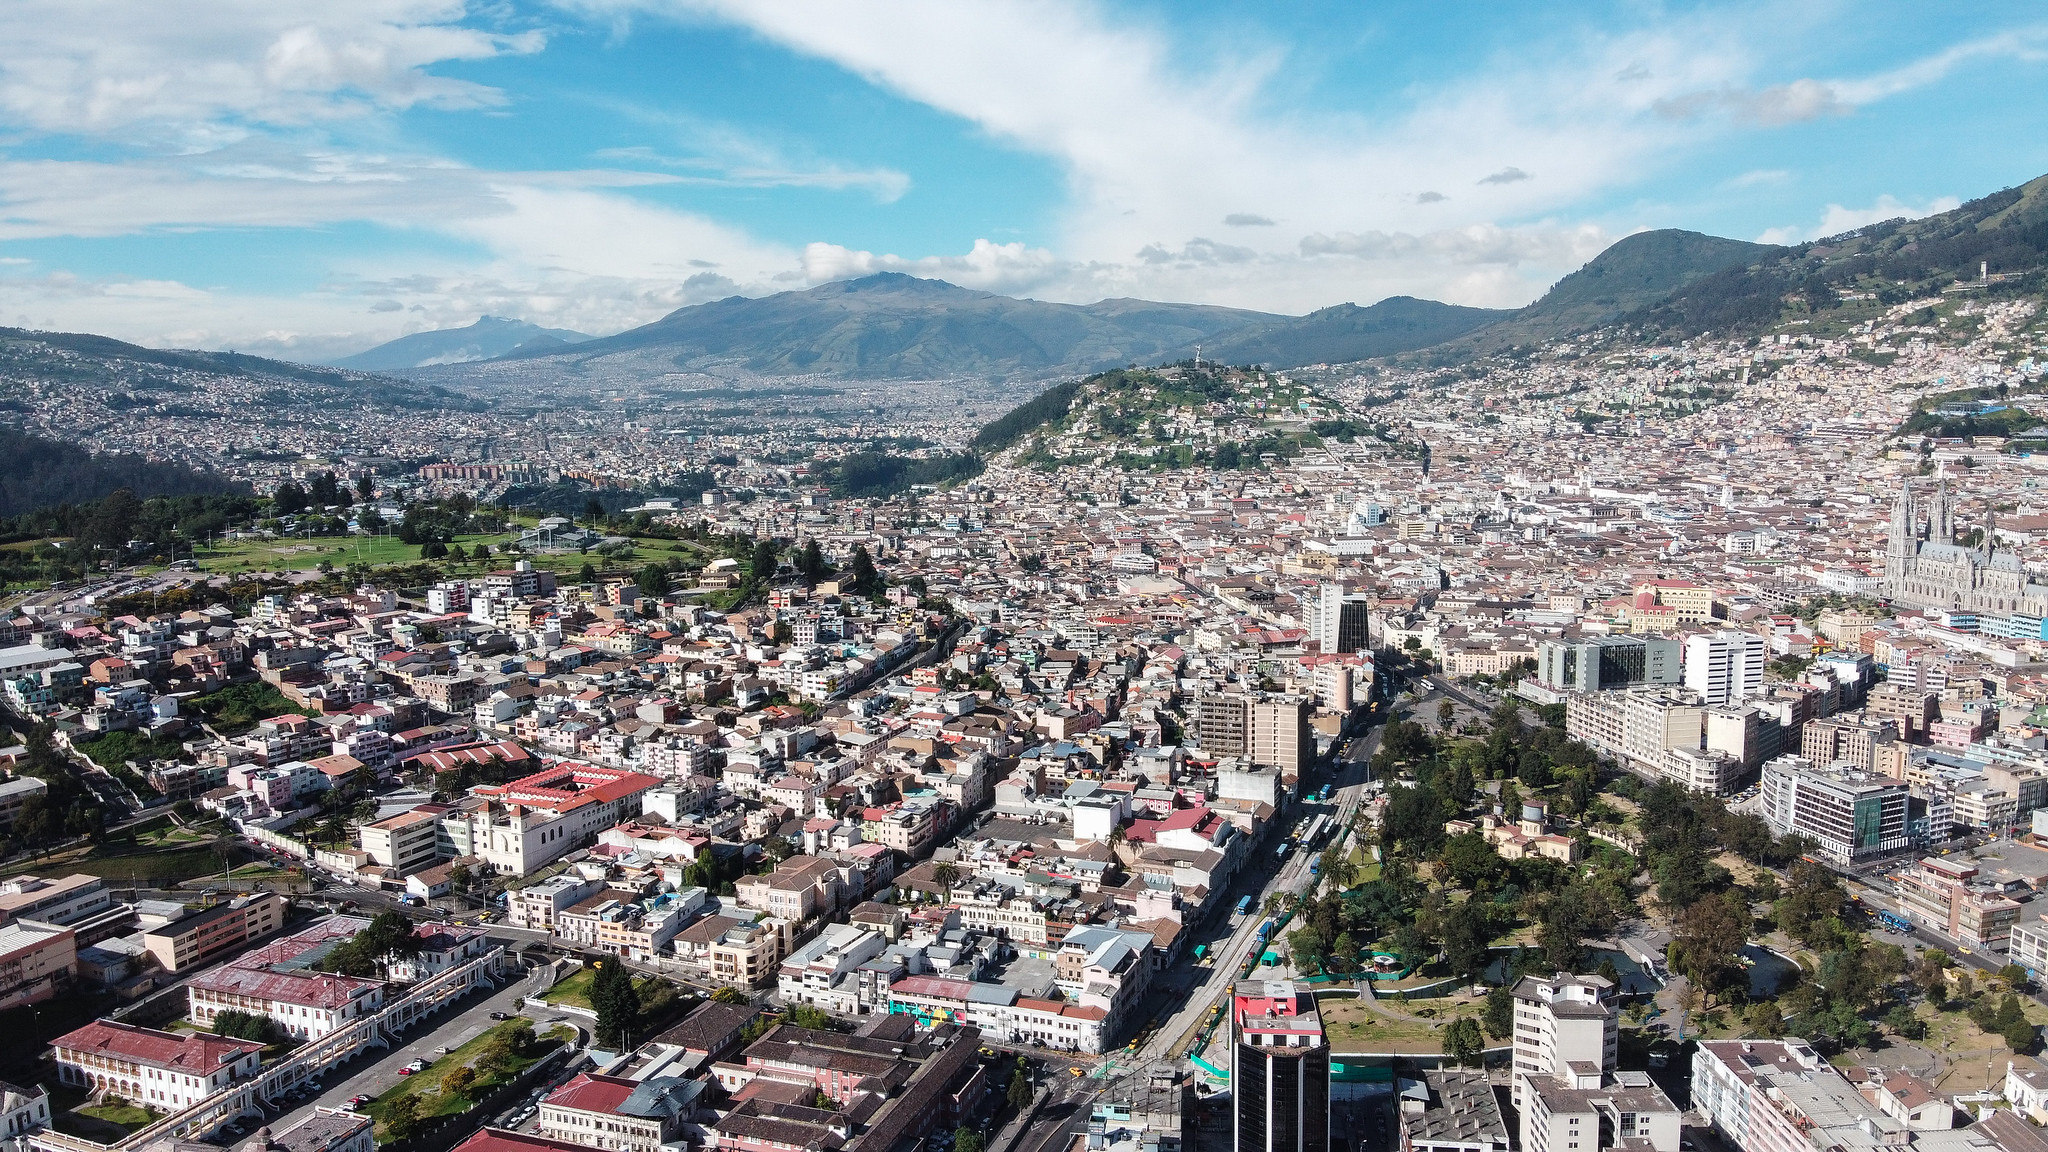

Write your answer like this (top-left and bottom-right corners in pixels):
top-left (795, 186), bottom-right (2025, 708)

top-left (16, 168), bottom-right (2048, 397)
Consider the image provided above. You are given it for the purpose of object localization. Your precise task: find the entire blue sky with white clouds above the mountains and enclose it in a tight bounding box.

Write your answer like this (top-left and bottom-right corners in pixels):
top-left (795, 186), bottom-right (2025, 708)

top-left (0, 0), bottom-right (2048, 359)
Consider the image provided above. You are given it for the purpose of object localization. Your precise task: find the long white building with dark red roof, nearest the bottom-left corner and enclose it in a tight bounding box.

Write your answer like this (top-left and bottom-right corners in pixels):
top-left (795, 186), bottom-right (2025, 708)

top-left (51, 1021), bottom-right (262, 1111)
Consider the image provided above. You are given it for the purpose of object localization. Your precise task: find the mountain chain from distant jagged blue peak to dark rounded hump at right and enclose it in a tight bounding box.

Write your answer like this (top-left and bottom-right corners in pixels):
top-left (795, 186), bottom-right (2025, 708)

top-left (380, 230), bottom-right (1778, 383)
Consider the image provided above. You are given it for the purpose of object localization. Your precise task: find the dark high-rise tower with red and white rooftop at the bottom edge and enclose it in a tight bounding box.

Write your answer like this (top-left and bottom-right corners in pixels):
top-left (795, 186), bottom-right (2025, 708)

top-left (1231, 980), bottom-right (1331, 1152)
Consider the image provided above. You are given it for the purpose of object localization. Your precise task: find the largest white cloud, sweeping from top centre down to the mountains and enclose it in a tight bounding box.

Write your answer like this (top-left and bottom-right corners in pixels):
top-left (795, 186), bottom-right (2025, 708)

top-left (559, 0), bottom-right (1741, 312)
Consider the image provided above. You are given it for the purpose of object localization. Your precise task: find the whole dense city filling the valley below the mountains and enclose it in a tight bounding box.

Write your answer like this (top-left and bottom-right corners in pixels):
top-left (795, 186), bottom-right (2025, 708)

top-left (0, 293), bottom-right (2048, 1152)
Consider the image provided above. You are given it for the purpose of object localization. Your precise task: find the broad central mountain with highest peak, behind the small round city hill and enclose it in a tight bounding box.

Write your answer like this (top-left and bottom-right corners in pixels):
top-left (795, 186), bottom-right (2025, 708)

top-left (491, 273), bottom-right (1282, 379)
